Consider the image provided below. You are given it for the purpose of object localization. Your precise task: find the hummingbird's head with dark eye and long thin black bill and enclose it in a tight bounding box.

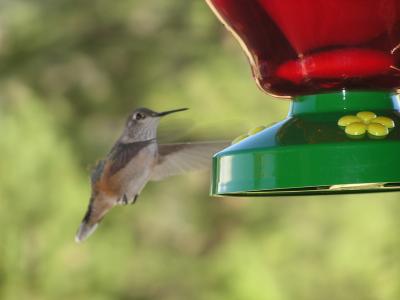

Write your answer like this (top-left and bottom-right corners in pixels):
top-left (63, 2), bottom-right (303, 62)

top-left (121, 108), bottom-right (187, 143)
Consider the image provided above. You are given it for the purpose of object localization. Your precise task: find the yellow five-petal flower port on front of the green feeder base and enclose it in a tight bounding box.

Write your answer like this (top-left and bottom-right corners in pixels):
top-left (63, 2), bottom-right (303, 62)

top-left (338, 111), bottom-right (395, 139)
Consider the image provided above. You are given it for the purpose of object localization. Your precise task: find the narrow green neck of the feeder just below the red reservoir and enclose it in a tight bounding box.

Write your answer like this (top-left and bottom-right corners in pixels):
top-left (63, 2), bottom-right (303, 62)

top-left (289, 90), bottom-right (400, 116)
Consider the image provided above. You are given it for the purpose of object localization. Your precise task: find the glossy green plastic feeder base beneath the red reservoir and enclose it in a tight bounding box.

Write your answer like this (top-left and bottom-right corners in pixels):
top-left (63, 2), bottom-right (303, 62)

top-left (211, 90), bottom-right (400, 196)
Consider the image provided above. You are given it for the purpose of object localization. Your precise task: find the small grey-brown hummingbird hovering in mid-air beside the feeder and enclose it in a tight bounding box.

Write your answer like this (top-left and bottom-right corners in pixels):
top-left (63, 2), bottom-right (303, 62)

top-left (75, 108), bottom-right (228, 243)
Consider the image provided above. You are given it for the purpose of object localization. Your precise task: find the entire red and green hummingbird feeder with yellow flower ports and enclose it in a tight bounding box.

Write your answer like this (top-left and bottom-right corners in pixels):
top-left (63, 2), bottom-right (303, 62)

top-left (206, 0), bottom-right (400, 196)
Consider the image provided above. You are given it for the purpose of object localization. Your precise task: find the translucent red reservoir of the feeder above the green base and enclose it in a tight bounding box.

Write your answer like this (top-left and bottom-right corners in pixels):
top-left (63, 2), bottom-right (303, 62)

top-left (206, 0), bottom-right (400, 97)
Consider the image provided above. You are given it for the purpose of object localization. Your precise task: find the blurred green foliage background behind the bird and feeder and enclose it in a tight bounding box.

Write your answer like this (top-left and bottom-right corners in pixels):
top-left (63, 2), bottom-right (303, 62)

top-left (0, 0), bottom-right (400, 300)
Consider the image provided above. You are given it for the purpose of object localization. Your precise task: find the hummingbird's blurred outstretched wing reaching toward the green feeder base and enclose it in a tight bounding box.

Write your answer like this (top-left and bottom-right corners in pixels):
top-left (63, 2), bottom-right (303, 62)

top-left (151, 141), bottom-right (229, 180)
